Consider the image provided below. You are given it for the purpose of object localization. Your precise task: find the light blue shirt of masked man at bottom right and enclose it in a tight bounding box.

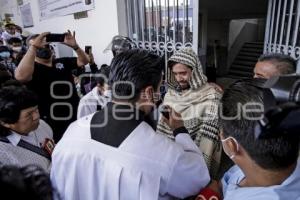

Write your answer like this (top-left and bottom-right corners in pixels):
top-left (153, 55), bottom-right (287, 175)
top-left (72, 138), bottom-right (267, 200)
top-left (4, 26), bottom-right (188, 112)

top-left (222, 162), bottom-right (300, 200)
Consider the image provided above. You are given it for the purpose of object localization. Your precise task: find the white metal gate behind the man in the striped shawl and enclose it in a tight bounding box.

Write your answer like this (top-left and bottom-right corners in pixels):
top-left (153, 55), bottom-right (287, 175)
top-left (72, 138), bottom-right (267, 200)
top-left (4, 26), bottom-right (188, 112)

top-left (126, 0), bottom-right (198, 71)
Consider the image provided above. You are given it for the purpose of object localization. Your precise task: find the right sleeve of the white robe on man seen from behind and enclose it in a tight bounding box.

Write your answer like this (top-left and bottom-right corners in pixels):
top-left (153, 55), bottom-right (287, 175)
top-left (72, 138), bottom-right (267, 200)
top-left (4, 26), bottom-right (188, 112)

top-left (167, 133), bottom-right (210, 198)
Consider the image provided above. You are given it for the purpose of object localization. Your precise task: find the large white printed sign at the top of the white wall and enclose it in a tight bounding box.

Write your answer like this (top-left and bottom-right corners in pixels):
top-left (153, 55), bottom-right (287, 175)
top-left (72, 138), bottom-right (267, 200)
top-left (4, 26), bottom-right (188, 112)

top-left (39, 0), bottom-right (95, 20)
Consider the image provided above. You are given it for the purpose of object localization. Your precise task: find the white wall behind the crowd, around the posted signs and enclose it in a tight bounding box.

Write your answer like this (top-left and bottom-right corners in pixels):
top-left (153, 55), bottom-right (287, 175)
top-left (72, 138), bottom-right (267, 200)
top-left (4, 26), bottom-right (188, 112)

top-left (0, 0), bottom-right (119, 66)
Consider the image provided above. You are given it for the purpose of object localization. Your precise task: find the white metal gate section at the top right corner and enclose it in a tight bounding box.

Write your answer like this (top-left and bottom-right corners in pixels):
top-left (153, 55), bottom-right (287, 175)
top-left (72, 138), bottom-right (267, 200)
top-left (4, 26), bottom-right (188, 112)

top-left (264, 0), bottom-right (300, 63)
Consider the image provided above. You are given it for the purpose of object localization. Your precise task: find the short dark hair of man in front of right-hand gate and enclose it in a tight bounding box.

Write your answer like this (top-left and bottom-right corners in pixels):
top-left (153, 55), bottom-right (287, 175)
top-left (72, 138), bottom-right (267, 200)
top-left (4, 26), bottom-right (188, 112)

top-left (258, 53), bottom-right (297, 75)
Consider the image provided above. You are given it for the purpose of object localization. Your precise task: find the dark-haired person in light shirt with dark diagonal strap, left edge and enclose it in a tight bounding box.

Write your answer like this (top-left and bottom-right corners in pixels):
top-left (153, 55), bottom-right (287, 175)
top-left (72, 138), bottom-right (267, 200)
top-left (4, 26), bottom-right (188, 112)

top-left (0, 82), bottom-right (54, 171)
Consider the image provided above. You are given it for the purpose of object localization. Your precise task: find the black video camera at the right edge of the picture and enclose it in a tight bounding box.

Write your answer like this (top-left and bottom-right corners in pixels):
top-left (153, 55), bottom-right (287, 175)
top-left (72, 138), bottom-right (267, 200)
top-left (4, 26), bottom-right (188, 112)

top-left (255, 75), bottom-right (300, 139)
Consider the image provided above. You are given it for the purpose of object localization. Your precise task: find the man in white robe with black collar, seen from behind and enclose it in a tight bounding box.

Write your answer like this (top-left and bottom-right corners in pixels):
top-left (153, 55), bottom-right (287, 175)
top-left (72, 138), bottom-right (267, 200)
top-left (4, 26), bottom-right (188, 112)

top-left (51, 50), bottom-right (210, 200)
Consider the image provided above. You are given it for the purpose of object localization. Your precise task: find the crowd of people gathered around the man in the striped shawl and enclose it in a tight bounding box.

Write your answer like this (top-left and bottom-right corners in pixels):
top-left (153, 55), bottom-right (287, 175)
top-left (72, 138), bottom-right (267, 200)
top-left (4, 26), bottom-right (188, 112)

top-left (0, 23), bottom-right (300, 200)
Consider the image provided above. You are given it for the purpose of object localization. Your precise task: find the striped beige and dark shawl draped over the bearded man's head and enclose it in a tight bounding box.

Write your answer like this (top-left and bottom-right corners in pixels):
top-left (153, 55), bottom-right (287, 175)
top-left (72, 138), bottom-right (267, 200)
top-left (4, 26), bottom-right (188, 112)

top-left (157, 48), bottom-right (222, 179)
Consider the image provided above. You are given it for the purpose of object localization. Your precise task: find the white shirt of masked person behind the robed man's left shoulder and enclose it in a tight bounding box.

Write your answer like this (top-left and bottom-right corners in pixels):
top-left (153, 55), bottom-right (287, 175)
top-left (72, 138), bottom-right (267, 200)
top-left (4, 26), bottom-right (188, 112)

top-left (77, 86), bottom-right (111, 119)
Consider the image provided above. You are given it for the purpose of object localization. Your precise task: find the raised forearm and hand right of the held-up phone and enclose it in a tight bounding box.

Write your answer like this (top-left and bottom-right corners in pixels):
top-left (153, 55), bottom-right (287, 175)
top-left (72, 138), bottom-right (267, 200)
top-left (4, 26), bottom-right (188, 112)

top-left (64, 30), bottom-right (90, 67)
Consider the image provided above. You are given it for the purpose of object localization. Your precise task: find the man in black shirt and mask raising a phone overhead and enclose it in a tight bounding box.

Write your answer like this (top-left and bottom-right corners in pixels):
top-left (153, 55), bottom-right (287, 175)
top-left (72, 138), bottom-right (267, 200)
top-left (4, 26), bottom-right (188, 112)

top-left (15, 31), bottom-right (89, 142)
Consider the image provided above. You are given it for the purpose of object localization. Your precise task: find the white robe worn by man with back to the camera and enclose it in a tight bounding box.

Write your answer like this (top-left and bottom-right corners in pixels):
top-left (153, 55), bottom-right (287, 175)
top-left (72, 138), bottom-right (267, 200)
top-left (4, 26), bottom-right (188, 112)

top-left (51, 115), bottom-right (210, 200)
